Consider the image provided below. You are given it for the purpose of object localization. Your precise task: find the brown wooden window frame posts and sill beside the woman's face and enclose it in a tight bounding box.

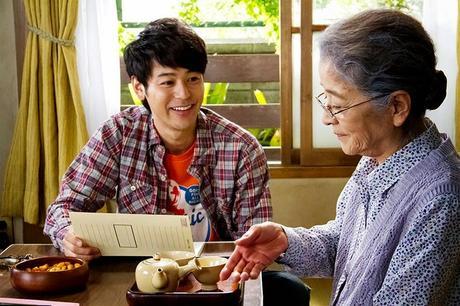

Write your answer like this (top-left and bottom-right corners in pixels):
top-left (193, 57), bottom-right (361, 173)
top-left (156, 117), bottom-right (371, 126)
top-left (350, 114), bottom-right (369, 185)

top-left (271, 0), bottom-right (359, 177)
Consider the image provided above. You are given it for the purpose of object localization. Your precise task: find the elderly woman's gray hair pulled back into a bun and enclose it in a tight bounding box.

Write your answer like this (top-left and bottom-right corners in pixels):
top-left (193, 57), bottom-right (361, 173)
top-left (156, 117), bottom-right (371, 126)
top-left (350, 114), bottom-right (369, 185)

top-left (320, 9), bottom-right (447, 123)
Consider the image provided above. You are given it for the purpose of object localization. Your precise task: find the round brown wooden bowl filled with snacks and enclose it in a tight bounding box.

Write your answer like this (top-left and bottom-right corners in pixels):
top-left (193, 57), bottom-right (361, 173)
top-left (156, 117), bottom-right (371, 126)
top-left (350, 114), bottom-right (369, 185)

top-left (10, 256), bottom-right (89, 294)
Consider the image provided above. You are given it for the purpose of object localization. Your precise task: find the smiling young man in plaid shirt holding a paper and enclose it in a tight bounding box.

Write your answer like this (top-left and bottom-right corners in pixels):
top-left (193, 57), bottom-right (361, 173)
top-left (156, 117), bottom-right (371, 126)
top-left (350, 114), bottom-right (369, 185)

top-left (44, 19), bottom-right (272, 259)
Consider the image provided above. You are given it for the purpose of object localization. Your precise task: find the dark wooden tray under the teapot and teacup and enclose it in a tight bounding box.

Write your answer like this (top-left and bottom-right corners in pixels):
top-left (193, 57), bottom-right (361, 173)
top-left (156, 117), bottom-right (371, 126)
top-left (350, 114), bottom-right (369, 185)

top-left (126, 274), bottom-right (244, 306)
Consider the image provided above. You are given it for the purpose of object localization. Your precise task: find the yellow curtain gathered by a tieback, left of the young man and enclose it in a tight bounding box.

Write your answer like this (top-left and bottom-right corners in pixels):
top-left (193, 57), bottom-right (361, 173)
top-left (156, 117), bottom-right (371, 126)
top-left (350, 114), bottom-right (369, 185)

top-left (0, 0), bottom-right (88, 224)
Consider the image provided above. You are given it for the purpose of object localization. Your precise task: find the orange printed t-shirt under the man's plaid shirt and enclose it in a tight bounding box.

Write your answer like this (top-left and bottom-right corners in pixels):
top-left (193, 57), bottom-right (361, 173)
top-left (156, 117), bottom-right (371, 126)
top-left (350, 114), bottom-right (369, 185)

top-left (165, 143), bottom-right (219, 241)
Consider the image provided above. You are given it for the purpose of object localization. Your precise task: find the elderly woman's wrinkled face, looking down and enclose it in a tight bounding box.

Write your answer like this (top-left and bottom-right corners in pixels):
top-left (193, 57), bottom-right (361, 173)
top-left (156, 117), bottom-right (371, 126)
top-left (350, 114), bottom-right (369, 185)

top-left (319, 60), bottom-right (399, 162)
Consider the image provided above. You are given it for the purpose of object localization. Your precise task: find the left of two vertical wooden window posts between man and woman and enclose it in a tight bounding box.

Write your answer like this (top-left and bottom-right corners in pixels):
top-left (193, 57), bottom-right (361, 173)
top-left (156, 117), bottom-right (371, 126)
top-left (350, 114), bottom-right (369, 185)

top-left (280, 0), bottom-right (292, 165)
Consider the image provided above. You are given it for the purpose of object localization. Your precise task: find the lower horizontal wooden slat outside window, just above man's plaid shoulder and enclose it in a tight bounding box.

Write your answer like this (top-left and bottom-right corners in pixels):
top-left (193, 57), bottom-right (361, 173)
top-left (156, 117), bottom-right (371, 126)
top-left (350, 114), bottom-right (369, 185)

top-left (204, 104), bottom-right (280, 128)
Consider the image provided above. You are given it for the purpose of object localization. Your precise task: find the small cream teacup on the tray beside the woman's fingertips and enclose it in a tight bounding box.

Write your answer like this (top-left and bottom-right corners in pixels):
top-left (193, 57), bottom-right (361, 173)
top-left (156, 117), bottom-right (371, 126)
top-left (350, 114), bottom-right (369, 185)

top-left (192, 256), bottom-right (227, 291)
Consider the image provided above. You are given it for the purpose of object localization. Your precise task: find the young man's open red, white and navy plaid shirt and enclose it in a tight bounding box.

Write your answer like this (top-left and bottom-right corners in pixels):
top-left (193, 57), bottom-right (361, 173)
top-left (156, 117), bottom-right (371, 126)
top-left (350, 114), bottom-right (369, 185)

top-left (44, 106), bottom-right (272, 247)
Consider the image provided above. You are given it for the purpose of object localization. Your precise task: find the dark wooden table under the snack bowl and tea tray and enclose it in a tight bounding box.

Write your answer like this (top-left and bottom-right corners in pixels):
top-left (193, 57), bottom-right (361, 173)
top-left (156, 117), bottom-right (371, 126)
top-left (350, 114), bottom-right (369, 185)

top-left (0, 242), bottom-right (263, 306)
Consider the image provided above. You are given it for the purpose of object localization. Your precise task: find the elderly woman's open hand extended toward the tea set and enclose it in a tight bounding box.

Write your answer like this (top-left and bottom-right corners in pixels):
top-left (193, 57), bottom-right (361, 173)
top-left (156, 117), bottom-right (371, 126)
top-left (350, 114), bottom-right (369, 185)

top-left (220, 222), bottom-right (288, 282)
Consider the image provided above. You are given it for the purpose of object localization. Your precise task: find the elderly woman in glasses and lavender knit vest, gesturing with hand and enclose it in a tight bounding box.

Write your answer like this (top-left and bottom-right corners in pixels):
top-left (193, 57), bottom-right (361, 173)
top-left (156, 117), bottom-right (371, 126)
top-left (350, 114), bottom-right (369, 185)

top-left (221, 10), bottom-right (460, 305)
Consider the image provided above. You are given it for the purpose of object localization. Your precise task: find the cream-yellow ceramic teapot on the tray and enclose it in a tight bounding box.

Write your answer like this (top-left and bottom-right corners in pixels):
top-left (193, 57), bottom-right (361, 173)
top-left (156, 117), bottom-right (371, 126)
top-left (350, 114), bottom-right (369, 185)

top-left (136, 254), bottom-right (200, 293)
